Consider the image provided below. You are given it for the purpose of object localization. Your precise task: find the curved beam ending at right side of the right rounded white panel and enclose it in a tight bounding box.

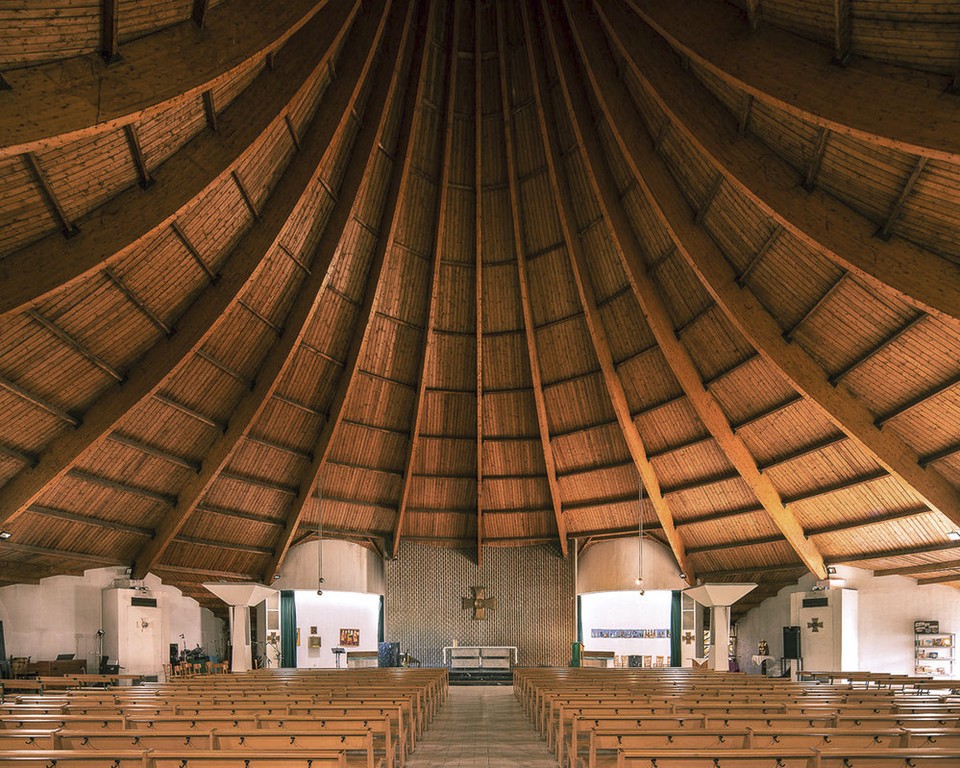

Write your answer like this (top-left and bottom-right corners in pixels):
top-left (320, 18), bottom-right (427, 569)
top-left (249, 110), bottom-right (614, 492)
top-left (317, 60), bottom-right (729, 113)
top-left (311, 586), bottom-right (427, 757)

top-left (521, 0), bottom-right (684, 583)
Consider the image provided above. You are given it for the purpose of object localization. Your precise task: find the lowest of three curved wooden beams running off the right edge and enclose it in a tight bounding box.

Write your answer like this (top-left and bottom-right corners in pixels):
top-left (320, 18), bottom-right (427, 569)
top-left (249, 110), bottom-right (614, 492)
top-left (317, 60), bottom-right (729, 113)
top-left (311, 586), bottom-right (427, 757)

top-left (588, 1), bottom-right (960, 523)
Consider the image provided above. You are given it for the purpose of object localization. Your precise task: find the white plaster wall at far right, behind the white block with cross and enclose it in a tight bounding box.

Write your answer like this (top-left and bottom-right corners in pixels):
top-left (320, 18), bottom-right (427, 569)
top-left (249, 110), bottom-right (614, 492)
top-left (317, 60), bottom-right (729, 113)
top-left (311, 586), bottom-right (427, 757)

top-left (737, 566), bottom-right (960, 675)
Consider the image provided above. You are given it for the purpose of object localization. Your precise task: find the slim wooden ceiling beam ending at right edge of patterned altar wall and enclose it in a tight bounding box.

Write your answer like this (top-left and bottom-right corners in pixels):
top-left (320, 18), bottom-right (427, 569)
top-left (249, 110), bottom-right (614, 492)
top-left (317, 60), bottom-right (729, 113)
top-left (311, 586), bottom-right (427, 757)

top-left (496, 0), bottom-right (569, 557)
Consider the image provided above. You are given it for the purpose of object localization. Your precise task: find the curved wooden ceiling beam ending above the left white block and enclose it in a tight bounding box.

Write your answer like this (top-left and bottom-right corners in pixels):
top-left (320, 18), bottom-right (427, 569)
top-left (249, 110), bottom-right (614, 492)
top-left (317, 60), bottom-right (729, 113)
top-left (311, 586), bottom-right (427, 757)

top-left (133, 2), bottom-right (398, 579)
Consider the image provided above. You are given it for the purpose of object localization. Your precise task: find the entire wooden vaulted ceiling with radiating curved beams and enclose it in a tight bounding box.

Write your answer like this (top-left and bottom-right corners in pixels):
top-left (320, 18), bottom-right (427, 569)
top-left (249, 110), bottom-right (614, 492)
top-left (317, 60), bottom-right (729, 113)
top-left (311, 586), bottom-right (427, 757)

top-left (0, 0), bottom-right (960, 609)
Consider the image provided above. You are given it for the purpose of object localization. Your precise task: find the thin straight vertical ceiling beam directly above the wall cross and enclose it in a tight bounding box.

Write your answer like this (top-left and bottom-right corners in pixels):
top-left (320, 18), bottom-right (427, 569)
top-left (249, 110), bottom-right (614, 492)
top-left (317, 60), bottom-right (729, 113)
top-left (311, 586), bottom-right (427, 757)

top-left (473, 2), bottom-right (484, 568)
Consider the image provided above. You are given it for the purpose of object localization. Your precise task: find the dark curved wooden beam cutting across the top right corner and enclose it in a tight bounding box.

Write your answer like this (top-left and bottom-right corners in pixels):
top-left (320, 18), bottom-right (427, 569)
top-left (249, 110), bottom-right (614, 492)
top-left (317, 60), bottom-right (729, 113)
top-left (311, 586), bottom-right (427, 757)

top-left (626, 0), bottom-right (960, 163)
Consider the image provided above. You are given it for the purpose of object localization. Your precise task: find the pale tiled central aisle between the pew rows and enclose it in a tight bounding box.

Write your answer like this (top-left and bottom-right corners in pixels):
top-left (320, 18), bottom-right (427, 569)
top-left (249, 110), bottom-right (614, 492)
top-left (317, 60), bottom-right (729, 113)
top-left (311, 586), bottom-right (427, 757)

top-left (407, 685), bottom-right (557, 768)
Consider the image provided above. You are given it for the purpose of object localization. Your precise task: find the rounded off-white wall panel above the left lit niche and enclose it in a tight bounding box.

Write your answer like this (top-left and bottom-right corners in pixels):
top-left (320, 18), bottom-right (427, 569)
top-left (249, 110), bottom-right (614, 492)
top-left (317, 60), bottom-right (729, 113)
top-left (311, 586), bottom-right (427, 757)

top-left (273, 539), bottom-right (384, 595)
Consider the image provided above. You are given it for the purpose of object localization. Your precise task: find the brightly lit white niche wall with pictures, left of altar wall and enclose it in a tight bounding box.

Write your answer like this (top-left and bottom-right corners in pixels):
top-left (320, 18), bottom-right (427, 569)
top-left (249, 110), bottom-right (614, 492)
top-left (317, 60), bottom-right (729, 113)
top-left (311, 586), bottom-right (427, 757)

top-left (294, 589), bottom-right (380, 667)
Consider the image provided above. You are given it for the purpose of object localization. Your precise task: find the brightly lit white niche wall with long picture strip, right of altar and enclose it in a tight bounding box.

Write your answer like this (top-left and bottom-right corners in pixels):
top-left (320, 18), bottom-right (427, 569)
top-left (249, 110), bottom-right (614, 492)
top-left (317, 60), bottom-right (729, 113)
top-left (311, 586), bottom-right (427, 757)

top-left (580, 589), bottom-right (673, 666)
